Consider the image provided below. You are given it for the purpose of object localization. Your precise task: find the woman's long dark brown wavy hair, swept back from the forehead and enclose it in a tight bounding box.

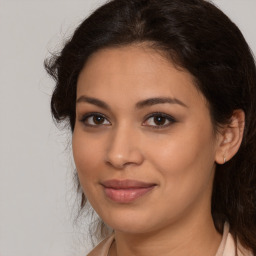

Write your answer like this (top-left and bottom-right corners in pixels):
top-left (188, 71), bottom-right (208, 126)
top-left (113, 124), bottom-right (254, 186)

top-left (45, 0), bottom-right (256, 253)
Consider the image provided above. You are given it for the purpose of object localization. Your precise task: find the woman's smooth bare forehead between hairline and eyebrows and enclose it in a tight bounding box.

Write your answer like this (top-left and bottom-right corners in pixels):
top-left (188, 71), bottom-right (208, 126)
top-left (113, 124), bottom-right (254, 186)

top-left (77, 45), bottom-right (204, 107)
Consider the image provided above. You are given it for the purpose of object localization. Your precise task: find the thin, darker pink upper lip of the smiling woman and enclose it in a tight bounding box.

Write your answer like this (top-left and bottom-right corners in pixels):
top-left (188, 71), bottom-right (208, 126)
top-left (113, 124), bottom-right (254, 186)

top-left (101, 180), bottom-right (156, 189)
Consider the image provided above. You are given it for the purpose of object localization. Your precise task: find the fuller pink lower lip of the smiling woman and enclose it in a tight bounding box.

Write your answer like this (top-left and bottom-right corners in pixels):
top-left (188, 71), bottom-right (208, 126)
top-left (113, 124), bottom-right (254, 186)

top-left (104, 186), bottom-right (155, 203)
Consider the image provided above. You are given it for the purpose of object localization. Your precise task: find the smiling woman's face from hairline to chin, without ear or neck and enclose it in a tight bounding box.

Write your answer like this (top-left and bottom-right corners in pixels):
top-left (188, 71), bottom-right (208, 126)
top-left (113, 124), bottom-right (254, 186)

top-left (73, 46), bottom-right (221, 233)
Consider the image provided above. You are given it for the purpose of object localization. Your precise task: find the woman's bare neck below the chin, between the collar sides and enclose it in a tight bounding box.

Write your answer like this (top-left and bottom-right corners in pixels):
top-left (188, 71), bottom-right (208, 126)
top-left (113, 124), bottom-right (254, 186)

top-left (110, 212), bottom-right (221, 256)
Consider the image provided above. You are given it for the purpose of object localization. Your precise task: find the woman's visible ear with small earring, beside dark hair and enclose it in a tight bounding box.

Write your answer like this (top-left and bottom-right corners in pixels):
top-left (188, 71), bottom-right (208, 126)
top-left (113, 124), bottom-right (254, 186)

top-left (215, 109), bottom-right (245, 164)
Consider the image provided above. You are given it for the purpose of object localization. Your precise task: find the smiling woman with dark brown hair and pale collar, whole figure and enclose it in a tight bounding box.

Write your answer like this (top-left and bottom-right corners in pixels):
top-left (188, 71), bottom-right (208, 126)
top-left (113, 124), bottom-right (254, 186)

top-left (46, 0), bottom-right (256, 256)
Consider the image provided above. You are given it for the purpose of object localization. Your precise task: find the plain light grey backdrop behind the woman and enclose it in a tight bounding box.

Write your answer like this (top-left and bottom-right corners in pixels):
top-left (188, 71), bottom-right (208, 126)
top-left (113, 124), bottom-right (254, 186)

top-left (0, 0), bottom-right (256, 256)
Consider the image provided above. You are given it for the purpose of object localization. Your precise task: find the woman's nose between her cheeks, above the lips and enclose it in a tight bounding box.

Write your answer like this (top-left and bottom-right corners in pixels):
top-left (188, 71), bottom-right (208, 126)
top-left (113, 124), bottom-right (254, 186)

top-left (105, 125), bottom-right (144, 169)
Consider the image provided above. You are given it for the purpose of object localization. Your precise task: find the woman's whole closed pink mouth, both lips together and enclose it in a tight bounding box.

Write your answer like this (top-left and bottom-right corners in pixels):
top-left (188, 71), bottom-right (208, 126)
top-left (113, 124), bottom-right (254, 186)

top-left (101, 180), bottom-right (156, 203)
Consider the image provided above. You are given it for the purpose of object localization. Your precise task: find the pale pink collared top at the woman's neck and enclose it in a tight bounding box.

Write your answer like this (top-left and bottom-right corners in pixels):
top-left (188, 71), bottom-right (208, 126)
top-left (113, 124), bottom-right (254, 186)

top-left (87, 223), bottom-right (253, 256)
